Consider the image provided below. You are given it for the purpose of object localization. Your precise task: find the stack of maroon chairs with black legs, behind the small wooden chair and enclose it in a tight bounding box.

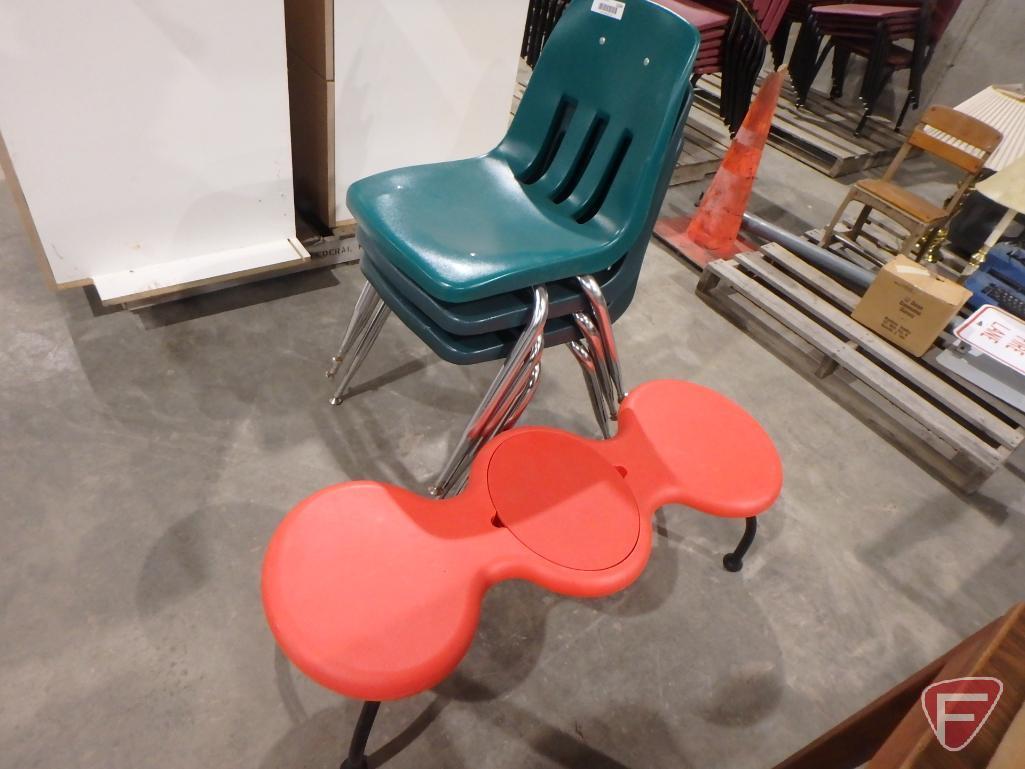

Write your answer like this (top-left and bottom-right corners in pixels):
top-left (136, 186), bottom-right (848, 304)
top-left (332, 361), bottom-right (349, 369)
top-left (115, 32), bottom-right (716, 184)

top-left (790, 0), bottom-right (961, 135)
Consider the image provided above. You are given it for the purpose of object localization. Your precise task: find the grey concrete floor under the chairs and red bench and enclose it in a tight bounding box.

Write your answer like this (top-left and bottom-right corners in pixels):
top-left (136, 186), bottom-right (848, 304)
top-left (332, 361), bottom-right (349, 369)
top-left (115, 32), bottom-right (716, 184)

top-left (0, 141), bottom-right (1025, 769)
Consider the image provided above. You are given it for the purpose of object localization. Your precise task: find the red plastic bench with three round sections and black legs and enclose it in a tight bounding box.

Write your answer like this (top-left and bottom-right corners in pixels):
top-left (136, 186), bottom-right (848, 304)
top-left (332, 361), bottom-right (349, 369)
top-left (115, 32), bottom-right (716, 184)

top-left (262, 380), bottom-right (782, 768)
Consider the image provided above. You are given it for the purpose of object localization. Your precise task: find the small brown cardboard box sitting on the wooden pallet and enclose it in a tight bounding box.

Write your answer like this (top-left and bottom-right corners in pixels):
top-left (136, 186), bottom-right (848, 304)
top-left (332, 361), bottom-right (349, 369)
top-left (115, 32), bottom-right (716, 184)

top-left (853, 256), bottom-right (972, 357)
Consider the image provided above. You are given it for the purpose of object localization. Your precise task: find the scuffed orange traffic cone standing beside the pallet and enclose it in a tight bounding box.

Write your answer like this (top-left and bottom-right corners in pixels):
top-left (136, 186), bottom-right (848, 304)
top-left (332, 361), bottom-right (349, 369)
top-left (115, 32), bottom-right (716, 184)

top-left (655, 70), bottom-right (785, 268)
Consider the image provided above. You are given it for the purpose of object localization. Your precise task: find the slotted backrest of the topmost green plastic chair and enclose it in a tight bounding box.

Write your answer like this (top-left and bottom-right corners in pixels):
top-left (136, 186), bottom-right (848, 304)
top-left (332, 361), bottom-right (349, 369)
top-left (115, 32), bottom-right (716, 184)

top-left (492, 0), bottom-right (700, 241)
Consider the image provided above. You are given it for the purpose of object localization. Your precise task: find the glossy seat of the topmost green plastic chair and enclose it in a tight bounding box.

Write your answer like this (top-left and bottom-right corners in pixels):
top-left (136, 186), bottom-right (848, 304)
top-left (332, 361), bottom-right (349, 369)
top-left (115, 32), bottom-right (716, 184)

top-left (349, 156), bottom-right (622, 302)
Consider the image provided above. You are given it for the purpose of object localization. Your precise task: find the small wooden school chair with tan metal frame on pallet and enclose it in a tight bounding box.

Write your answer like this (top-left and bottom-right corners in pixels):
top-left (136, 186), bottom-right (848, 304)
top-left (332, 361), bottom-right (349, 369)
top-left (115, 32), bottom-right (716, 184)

top-left (819, 106), bottom-right (1002, 256)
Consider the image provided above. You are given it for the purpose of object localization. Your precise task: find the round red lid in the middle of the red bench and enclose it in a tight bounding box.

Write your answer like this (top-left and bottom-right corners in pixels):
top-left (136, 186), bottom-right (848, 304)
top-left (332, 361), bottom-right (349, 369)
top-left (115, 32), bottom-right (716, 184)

top-left (488, 430), bottom-right (641, 571)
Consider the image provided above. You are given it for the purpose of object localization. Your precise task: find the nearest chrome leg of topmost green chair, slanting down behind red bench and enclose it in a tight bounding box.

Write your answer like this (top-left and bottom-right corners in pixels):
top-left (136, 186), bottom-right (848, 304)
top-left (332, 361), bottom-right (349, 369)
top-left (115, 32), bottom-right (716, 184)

top-left (428, 286), bottom-right (548, 496)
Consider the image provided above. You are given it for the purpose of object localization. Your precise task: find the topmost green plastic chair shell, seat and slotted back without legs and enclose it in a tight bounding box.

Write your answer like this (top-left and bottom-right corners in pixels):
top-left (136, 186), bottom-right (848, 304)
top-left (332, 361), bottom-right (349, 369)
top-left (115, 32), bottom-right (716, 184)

top-left (346, 0), bottom-right (699, 302)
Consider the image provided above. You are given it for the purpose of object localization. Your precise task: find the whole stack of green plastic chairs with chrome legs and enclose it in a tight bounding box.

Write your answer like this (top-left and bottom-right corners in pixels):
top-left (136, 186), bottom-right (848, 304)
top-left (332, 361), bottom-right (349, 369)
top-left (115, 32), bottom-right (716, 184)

top-left (328, 0), bottom-right (699, 496)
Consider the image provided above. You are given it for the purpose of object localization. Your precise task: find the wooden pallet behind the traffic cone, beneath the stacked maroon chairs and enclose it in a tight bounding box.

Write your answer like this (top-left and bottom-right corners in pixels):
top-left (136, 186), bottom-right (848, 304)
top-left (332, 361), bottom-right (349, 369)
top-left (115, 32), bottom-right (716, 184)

top-left (694, 75), bottom-right (904, 176)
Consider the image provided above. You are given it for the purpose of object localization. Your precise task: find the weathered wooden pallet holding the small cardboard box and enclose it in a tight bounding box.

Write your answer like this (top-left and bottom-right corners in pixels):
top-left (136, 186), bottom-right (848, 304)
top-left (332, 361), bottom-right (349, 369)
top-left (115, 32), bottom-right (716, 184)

top-left (697, 244), bottom-right (1025, 492)
